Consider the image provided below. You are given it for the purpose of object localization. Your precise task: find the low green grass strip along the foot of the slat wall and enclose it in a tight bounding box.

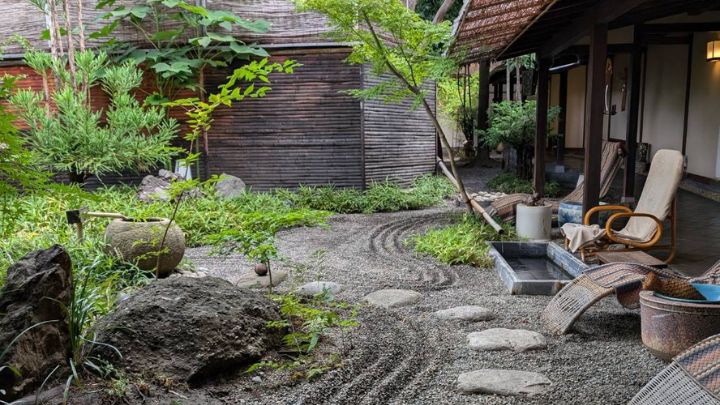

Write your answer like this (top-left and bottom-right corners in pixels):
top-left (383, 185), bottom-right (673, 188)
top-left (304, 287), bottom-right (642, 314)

top-left (284, 175), bottom-right (455, 214)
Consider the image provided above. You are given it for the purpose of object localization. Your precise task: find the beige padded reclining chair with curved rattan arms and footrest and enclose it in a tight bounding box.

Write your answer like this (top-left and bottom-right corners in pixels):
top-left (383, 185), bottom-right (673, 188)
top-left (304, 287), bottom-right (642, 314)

top-left (562, 149), bottom-right (684, 263)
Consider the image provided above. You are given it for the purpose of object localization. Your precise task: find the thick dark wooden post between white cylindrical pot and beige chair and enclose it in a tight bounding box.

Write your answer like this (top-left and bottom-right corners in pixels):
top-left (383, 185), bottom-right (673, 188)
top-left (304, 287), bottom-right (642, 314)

top-left (583, 24), bottom-right (608, 223)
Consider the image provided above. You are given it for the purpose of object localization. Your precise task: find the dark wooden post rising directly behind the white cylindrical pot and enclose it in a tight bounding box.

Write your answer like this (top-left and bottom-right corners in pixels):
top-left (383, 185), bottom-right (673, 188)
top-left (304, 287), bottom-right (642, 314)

top-left (533, 55), bottom-right (550, 198)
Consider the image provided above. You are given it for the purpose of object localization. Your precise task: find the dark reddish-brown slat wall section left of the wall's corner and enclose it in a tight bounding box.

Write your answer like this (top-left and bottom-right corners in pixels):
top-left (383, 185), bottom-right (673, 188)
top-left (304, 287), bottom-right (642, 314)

top-left (202, 49), bottom-right (362, 190)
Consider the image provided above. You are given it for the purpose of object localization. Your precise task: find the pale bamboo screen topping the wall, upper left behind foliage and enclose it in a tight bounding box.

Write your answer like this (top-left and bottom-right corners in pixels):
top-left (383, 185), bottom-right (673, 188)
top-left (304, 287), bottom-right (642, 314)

top-left (0, 0), bottom-right (333, 54)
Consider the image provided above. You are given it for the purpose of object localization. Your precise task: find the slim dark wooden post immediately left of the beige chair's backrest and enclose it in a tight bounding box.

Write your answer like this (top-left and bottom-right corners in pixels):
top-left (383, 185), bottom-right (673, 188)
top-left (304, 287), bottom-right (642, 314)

top-left (622, 27), bottom-right (642, 203)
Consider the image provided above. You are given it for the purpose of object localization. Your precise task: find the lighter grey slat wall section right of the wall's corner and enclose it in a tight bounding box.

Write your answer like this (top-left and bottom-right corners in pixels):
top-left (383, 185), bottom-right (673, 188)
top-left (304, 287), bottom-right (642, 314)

top-left (363, 69), bottom-right (436, 185)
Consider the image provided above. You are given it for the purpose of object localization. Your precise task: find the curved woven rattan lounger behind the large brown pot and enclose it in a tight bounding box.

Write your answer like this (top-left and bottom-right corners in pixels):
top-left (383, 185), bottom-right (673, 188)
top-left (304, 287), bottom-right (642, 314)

top-left (540, 261), bottom-right (720, 334)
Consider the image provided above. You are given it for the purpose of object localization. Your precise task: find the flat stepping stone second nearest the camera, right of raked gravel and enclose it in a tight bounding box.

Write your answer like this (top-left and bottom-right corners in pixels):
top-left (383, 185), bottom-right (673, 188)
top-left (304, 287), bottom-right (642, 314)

top-left (468, 328), bottom-right (547, 352)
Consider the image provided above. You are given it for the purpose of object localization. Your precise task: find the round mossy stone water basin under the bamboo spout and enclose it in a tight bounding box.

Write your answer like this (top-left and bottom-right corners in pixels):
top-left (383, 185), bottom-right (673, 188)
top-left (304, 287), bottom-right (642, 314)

top-left (105, 218), bottom-right (185, 277)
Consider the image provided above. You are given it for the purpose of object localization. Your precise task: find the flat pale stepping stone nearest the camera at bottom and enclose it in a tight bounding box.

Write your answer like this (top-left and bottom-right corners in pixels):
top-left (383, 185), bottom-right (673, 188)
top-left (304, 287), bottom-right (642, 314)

top-left (457, 369), bottom-right (552, 396)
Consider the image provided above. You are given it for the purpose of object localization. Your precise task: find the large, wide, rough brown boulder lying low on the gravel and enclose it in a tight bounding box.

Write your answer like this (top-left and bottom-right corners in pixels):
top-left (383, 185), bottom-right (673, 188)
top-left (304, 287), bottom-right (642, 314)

top-left (97, 277), bottom-right (282, 386)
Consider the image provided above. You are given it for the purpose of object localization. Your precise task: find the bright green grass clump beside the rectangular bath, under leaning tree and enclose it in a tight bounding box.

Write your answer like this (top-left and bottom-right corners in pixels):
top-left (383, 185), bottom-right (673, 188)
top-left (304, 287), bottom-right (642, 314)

top-left (407, 214), bottom-right (516, 268)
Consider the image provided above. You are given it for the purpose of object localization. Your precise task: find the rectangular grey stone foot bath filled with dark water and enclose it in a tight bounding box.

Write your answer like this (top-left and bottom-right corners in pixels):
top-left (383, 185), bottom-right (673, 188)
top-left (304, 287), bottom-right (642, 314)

top-left (488, 242), bottom-right (588, 295)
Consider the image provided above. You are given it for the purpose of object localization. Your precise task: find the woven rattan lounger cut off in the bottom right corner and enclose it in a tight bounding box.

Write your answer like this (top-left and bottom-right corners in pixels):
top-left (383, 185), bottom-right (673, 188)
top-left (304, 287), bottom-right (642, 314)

top-left (629, 335), bottom-right (720, 405)
